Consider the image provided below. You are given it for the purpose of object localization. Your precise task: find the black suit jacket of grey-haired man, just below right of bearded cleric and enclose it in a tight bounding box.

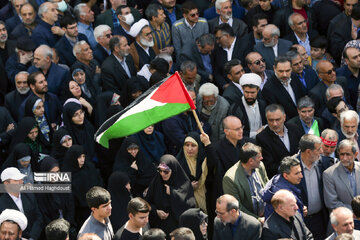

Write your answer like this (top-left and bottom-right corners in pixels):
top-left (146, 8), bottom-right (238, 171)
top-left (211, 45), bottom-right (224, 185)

top-left (256, 123), bottom-right (302, 178)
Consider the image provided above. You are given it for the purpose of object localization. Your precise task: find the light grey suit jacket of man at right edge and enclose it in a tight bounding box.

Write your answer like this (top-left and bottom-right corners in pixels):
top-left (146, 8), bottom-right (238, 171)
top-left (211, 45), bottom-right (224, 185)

top-left (323, 162), bottom-right (360, 209)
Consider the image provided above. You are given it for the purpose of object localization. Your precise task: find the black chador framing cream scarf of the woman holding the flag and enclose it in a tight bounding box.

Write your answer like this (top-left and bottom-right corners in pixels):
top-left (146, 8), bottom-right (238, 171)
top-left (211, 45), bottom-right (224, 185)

top-left (176, 132), bottom-right (205, 181)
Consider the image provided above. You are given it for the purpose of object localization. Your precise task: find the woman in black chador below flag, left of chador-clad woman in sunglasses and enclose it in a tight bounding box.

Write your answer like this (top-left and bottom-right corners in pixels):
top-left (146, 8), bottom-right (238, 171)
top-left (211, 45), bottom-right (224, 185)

top-left (113, 137), bottom-right (156, 197)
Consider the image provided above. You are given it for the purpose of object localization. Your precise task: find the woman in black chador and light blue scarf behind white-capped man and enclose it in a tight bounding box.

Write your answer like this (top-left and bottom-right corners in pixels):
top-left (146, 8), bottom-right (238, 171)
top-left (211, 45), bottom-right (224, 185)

top-left (1, 143), bottom-right (38, 184)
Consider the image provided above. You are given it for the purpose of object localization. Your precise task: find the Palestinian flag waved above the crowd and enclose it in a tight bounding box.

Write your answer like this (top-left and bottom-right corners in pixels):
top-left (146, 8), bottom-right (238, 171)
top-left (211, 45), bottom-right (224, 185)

top-left (95, 72), bottom-right (195, 148)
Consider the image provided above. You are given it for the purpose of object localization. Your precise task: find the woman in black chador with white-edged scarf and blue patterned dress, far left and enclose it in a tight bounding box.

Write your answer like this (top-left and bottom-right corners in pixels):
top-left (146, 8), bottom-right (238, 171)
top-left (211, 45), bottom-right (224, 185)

top-left (24, 95), bottom-right (53, 143)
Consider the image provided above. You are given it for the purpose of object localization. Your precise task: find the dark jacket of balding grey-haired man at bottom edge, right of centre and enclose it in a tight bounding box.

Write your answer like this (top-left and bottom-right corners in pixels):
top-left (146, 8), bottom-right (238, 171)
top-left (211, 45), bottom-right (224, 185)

top-left (213, 211), bottom-right (261, 240)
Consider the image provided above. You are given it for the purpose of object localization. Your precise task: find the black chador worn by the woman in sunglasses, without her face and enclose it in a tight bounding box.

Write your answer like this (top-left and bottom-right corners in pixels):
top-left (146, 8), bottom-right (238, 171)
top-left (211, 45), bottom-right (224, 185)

top-left (146, 154), bottom-right (195, 220)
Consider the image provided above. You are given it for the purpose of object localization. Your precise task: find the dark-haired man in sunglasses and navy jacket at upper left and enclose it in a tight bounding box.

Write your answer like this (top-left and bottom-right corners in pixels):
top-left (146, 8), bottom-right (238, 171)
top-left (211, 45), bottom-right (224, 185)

top-left (55, 15), bottom-right (88, 66)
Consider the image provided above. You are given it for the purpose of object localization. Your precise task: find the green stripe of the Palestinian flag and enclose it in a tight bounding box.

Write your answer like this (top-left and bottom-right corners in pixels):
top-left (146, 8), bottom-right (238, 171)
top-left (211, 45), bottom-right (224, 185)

top-left (99, 103), bottom-right (190, 146)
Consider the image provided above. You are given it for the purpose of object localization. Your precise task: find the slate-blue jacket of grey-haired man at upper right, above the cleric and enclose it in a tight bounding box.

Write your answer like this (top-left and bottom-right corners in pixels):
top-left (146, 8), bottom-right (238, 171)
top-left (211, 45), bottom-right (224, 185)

top-left (254, 38), bottom-right (293, 70)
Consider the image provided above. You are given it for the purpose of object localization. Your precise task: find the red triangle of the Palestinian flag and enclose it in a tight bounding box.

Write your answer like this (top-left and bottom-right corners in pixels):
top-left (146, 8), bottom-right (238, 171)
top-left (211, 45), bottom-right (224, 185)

top-left (151, 72), bottom-right (196, 109)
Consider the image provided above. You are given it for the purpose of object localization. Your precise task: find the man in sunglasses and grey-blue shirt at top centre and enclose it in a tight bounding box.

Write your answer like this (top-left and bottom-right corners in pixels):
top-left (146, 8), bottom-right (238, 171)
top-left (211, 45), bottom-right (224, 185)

top-left (171, 1), bottom-right (209, 57)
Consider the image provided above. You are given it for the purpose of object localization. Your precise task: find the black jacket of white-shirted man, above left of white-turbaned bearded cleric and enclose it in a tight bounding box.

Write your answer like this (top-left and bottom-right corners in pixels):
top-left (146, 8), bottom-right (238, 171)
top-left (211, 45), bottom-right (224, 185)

top-left (213, 38), bottom-right (247, 88)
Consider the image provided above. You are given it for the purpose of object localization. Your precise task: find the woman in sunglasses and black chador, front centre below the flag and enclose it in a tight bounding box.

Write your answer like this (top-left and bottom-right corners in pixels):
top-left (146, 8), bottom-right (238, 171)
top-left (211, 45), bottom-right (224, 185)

top-left (146, 154), bottom-right (196, 235)
